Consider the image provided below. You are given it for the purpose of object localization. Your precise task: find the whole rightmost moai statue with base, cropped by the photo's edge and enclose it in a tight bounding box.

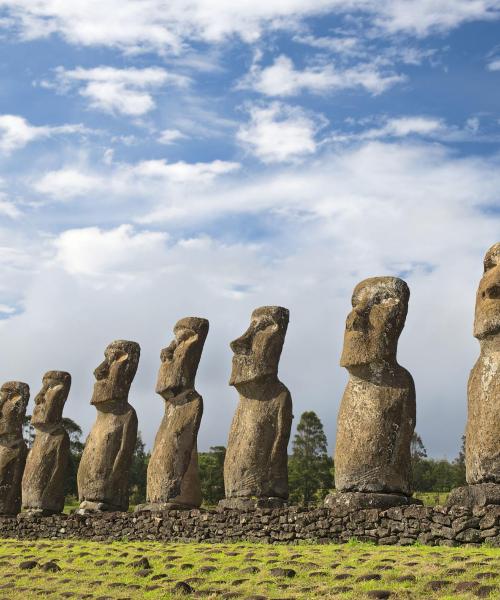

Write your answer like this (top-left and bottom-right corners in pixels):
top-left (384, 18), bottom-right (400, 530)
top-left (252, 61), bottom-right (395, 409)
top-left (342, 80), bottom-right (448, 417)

top-left (448, 243), bottom-right (500, 507)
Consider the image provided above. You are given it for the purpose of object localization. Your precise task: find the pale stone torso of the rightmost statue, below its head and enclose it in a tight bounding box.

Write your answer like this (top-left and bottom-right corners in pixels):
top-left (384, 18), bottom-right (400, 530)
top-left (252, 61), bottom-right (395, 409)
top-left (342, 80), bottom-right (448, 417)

top-left (466, 348), bottom-right (500, 484)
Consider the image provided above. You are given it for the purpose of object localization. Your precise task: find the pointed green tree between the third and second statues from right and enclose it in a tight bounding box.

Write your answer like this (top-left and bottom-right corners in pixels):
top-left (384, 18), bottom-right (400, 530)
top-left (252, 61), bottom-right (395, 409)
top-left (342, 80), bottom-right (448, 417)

top-left (288, 411), bottom-right (333, 505)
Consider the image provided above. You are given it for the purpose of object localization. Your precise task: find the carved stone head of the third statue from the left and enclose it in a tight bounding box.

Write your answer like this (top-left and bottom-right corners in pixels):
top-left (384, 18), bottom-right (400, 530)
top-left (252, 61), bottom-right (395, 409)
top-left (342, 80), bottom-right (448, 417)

top-left (90, 340), bottom-right (141, 405)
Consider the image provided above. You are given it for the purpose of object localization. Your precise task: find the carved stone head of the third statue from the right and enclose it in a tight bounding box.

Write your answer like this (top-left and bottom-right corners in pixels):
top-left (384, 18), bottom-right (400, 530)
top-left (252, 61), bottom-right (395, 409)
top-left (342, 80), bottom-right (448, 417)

top-left (229, 306), bottom-right (289, 386)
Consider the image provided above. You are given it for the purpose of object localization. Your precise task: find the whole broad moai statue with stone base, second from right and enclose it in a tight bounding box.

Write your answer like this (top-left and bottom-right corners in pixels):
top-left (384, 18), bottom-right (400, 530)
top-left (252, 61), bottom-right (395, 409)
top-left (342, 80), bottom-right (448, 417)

top-left (325, 277), bottom-right (416, 509)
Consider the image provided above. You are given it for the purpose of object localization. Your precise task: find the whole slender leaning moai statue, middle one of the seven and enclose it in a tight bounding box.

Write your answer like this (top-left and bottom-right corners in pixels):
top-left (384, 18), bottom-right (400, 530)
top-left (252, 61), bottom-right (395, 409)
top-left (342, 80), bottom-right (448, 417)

top-left (136, 317), bottom-right (208, 511)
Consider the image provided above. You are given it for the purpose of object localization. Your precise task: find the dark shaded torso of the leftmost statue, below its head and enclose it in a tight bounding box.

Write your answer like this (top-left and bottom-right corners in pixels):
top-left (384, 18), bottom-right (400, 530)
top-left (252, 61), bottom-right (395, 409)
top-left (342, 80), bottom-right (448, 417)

top-left (0, 440), bottom-right (28, 515)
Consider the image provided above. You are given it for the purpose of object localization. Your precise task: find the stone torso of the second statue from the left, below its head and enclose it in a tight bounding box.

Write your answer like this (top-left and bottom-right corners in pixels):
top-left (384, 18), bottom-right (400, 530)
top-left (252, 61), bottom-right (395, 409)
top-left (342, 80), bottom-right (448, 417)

top-left (22, 430), bottom-right (69, 512)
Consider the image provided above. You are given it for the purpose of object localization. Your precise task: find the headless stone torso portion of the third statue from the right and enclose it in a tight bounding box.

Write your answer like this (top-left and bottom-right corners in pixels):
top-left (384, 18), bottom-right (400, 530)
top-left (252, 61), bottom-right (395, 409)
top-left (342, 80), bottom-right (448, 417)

top-left (224, 384), bottom-right (293, 499)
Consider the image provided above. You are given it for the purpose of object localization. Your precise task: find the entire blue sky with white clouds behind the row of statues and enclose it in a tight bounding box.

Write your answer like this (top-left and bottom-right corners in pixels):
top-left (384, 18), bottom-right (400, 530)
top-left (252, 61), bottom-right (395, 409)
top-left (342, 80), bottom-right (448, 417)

top-left (0, 0), bottom-right (500, 458)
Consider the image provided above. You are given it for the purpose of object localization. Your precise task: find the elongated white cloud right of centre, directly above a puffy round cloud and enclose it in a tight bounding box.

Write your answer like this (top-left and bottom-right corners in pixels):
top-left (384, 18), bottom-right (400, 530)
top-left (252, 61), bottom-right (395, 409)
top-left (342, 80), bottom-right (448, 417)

top-left (240, 55), bottom-right (405, 96)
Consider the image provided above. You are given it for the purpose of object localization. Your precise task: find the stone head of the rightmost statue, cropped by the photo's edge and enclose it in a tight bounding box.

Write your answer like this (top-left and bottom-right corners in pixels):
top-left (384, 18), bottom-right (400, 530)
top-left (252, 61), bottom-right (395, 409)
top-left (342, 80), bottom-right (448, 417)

top-left (474, 243), bottom-right (500, 340)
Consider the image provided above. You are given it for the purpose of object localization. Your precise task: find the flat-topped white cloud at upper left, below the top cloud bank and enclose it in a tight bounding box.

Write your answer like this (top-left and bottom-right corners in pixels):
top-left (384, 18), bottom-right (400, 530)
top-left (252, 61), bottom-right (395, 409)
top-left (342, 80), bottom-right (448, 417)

top-left (51, 66), bottom-right (189, 117)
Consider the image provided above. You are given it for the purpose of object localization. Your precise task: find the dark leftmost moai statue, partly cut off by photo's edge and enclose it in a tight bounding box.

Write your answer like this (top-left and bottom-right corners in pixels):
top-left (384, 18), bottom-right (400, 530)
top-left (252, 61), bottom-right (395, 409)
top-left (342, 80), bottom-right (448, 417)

top-left (0, 381), bottom-right (30, 515)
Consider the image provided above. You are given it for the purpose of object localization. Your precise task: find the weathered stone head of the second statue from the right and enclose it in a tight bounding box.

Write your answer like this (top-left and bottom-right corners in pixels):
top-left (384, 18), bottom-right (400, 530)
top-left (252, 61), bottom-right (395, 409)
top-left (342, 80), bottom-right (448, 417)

top-left (340, 277), bottom-right (410, 367)
